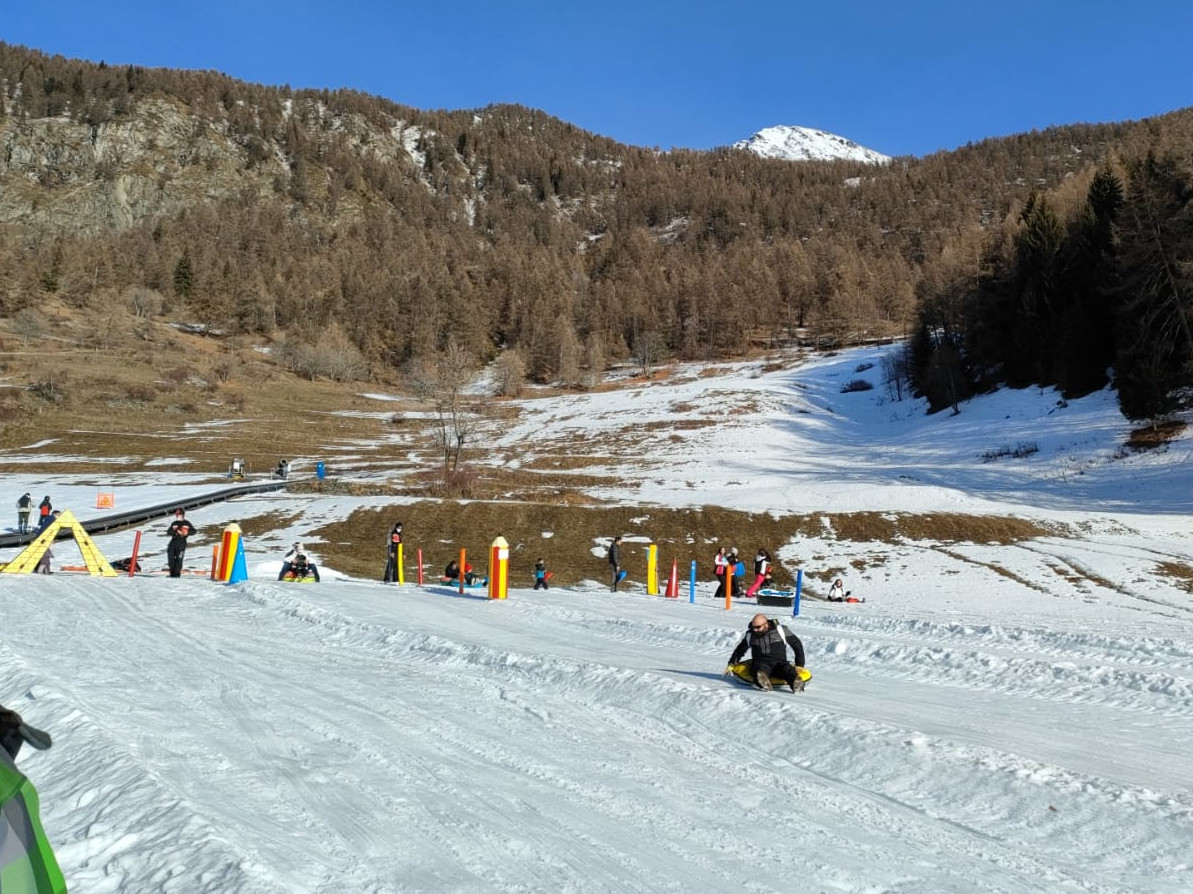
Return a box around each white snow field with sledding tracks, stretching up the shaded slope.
[0,349,1193,894]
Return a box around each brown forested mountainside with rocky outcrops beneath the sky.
[0,43,1193,405]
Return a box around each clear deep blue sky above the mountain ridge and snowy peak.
[0,0,1193,155]
